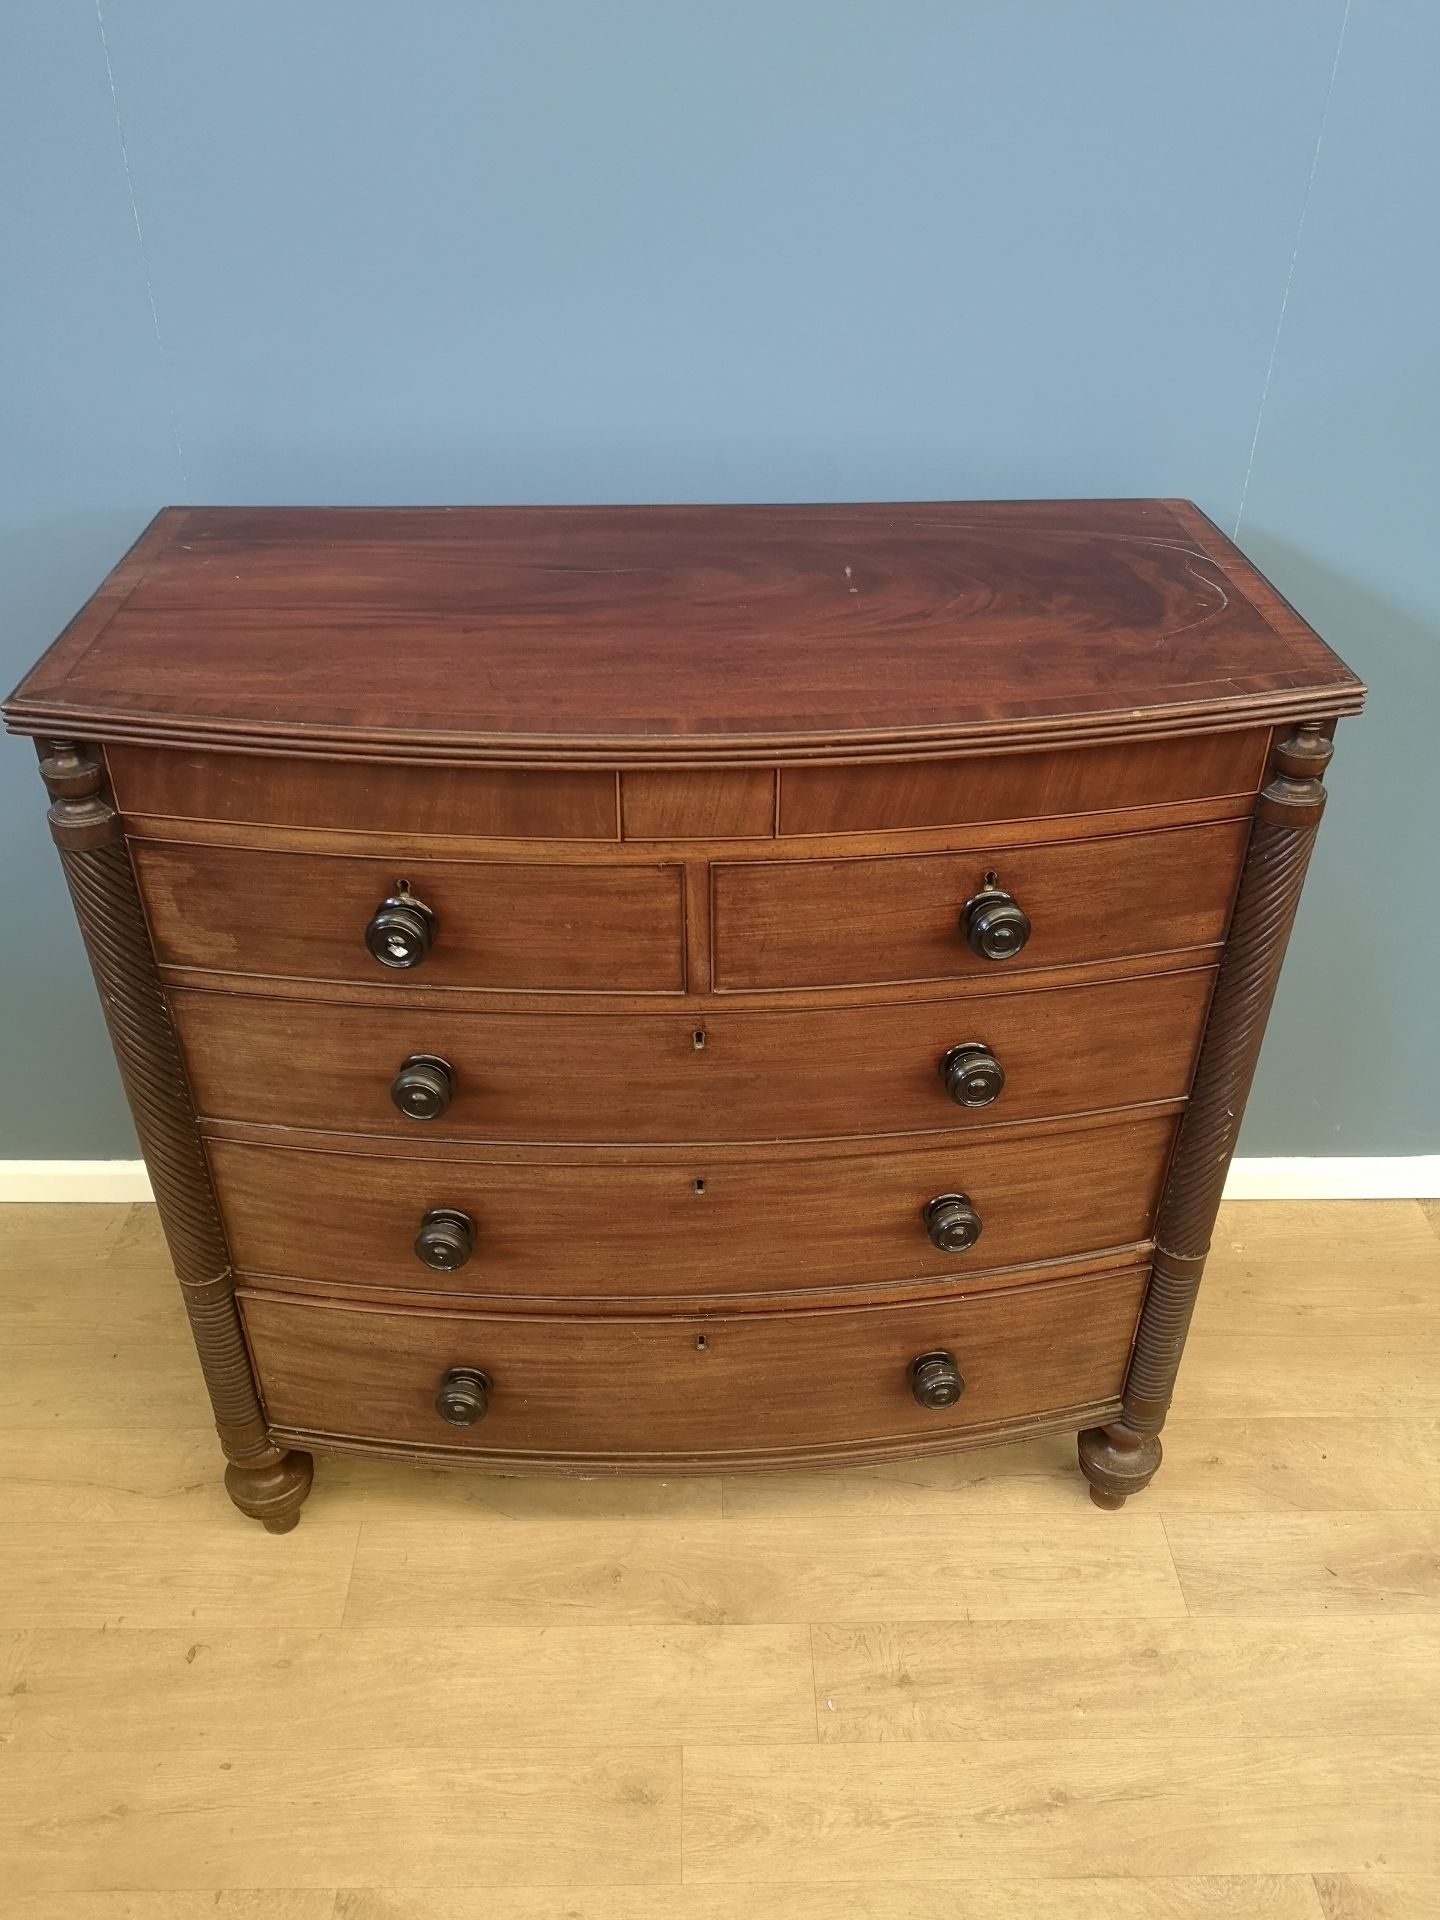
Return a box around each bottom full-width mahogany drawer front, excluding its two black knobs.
[240,1267,1148,1465]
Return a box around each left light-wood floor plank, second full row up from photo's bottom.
[13,1622,816,1753]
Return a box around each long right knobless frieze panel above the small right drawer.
[780,728,1269,835]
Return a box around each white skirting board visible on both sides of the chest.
[0,1154,1440,1202]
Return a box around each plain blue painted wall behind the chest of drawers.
[0,0,1440,1156]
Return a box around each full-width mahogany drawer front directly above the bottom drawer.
[209,1116,1175,1300]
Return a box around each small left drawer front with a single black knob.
[132,841,685,993]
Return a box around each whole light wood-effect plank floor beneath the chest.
[0,1202,1440,1920]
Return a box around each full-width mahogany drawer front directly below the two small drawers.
[171,968,1213,1142]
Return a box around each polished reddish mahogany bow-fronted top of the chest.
[6,501,1363,766]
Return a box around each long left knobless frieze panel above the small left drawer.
[106,747,620,841]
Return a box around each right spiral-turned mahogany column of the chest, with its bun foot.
[1079,722,1334,1507]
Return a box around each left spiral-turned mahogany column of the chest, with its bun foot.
[40,739,311,1534]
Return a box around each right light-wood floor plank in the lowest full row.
[685,1738,1440,1887]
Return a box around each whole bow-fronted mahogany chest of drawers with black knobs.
[6,501,1363,1532]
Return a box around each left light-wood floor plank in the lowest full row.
[0,1758,683,1895]
